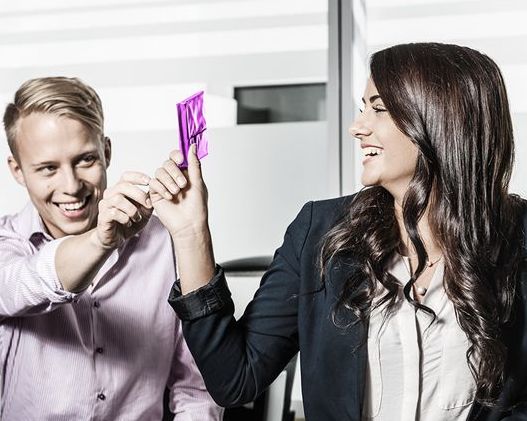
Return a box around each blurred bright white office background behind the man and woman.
[0,0,527,416]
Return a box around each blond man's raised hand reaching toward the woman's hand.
[92,171,153,249]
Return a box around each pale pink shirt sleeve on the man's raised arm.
[0,236,79,320]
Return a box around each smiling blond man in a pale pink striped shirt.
[0,77,223,421]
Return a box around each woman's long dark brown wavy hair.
[319,43,523,405]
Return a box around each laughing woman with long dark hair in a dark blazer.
[147,43,527,421]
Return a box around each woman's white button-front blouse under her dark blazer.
[363,258,476,421]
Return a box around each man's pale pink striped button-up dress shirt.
[0,204,223,421]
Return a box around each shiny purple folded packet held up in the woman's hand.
[177,91,209,168]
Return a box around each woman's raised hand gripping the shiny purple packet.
[150,145,208,243]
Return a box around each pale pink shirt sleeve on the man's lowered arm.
[168,321,224,421]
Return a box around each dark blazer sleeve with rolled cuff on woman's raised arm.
[169,202,313,407]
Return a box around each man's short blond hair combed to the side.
[4,76,104,158]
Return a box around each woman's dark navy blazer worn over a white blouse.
[169,197,527,421]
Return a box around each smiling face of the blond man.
[9,113,111,238]
